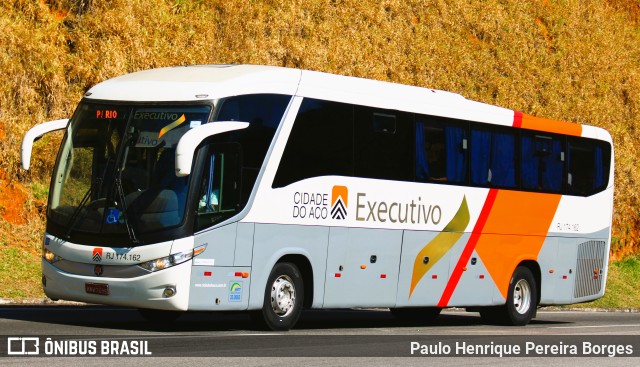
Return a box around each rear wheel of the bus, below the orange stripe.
[480,266,538,326]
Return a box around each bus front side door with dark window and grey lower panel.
[189,143,249,310]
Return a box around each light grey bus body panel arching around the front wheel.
[249,224,329,310]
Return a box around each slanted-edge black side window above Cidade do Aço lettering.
[273,99,353,188]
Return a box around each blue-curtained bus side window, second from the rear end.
[520,134,565,192]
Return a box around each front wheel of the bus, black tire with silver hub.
[251,263,304,331]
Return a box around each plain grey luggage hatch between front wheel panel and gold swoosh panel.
[323,227,402,308]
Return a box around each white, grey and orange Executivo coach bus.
[22,65,613,330]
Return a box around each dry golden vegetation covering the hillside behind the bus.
[0,0,640,298]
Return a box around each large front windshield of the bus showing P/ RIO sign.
[48,103,211,242]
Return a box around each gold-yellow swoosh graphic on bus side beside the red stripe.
[409,197,470,298]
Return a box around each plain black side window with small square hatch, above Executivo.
[354,106,413,181]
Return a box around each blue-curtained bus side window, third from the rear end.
[471,129,517,188]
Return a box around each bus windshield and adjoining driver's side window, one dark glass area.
[47,94,291,247]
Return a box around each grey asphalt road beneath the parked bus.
[0,305,640,367]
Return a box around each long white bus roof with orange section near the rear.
[85,65,611,141]
